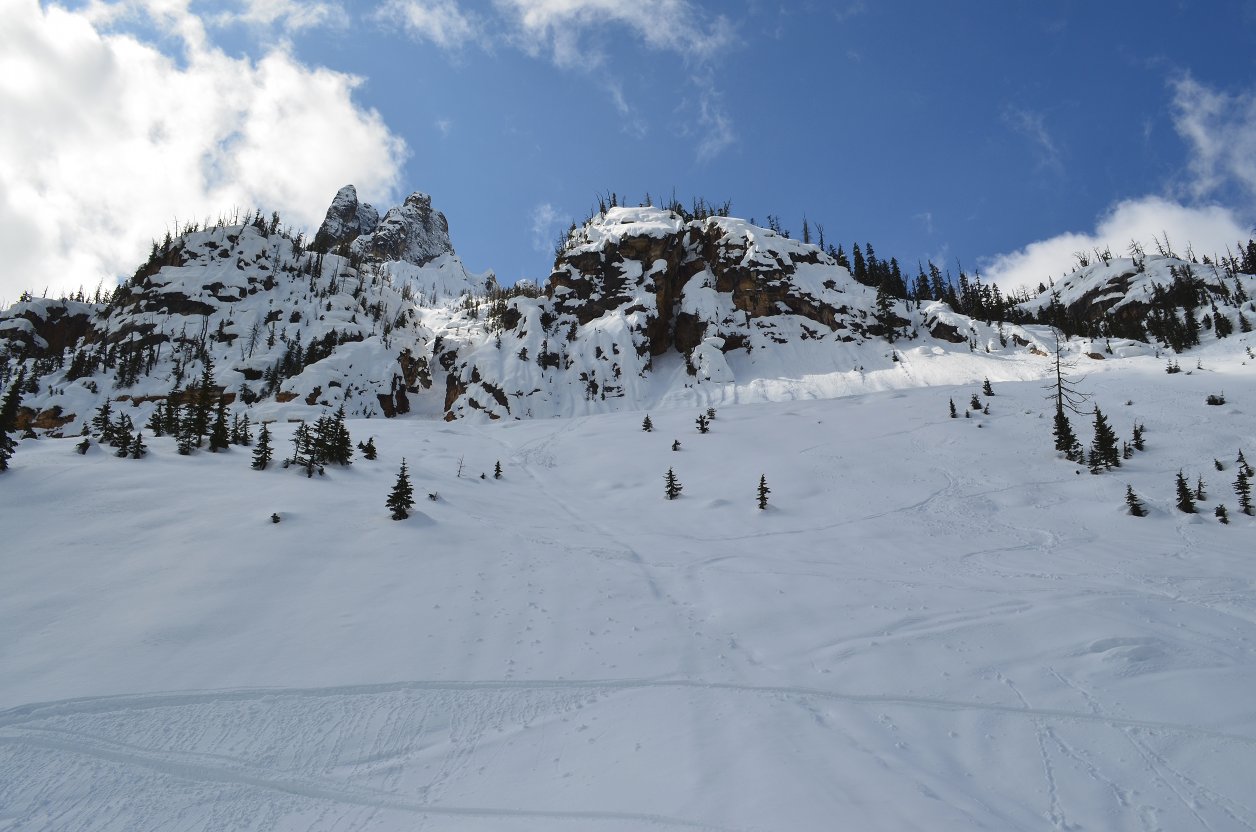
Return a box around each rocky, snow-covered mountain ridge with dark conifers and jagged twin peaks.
[0,186,1256,434]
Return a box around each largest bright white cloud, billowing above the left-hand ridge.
[0,0,406,300]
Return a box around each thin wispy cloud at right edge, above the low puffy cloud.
[1171,75,1256,204]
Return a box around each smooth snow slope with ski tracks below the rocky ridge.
[0,339,1256,832]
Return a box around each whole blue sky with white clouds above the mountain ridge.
[0,0,1256,300]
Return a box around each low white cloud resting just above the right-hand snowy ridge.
[982,196,1251,293]
